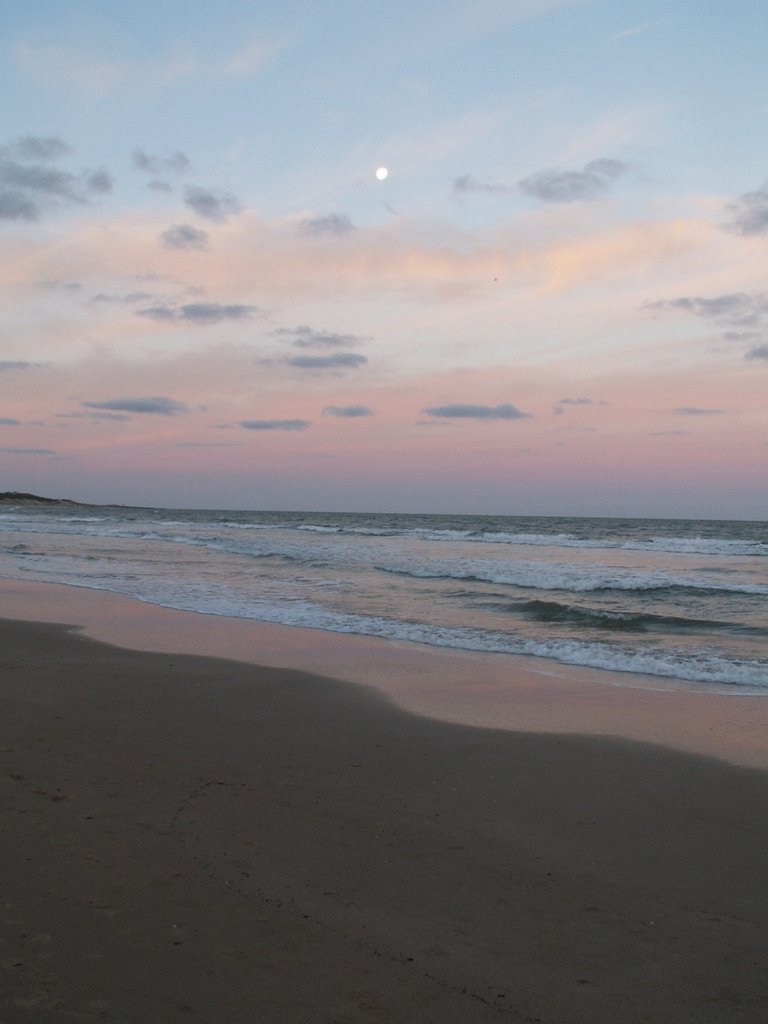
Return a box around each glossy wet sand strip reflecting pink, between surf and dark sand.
[0,579,768,769]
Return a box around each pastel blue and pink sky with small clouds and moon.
[0,0,768,519]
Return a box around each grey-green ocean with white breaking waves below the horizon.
[0,504,768,694]
